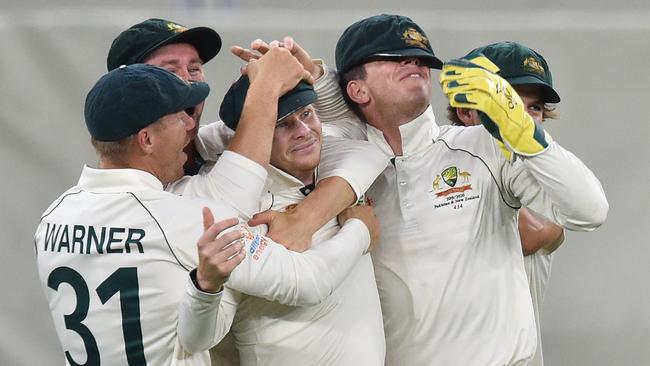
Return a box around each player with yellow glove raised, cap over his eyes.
[308,14,608,365]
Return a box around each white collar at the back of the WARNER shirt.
[77,165,163,192]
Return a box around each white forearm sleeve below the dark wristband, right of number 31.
[177,277,242,353]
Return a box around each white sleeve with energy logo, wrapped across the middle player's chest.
[225,219,370,306]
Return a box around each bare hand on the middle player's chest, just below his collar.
[248,206,314,253]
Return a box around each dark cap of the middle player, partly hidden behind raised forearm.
[219,75,316,131]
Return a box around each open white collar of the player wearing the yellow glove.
[367,105,440,156]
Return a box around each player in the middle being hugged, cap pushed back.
[180,76,387,366]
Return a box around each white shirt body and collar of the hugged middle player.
[233,165,385,366]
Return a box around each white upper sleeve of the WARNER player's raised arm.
[165,151,268,220]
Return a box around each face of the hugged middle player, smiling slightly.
[271,105,322,184]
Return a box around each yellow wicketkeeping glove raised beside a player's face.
[440,56,552,160]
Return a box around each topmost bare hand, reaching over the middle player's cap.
[230,36,323,80]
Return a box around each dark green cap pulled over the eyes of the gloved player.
[336,14,442,73]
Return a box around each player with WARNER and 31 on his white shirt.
[35,59,378,365]
